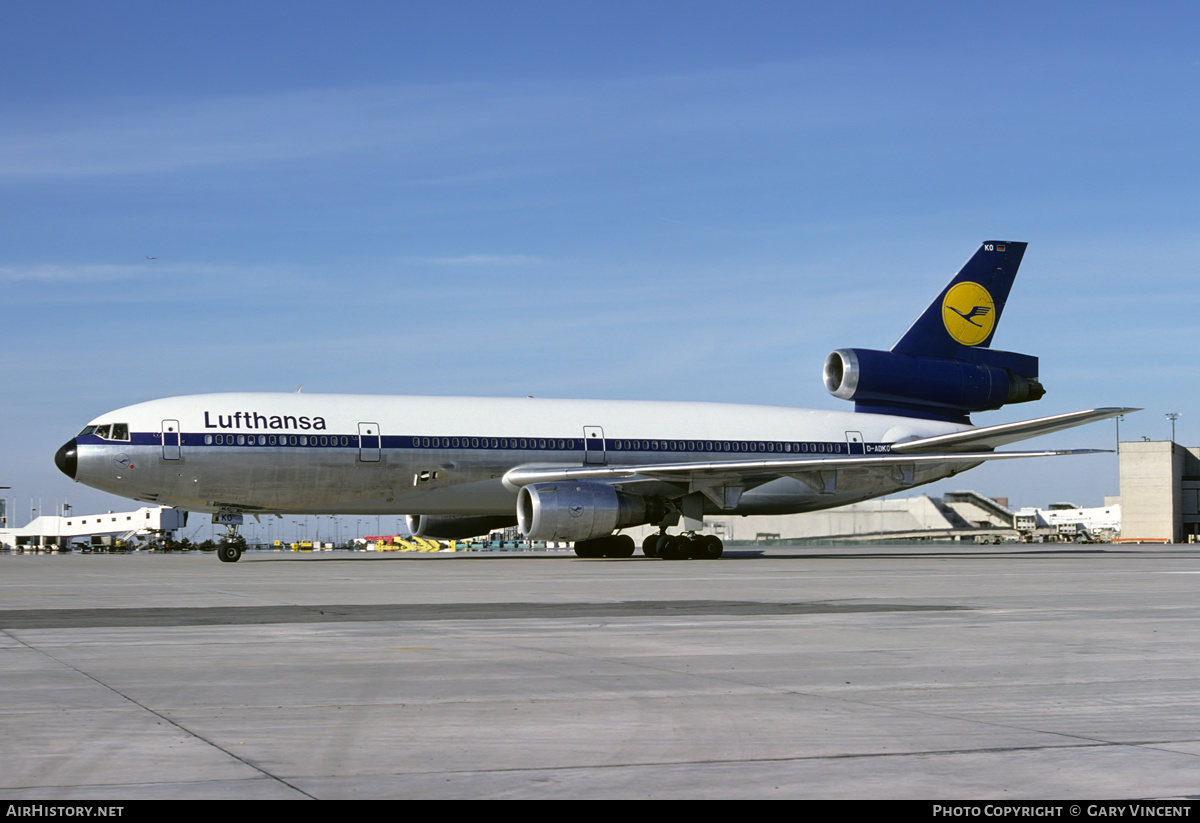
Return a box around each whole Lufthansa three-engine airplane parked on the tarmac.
[54,241,1136,563]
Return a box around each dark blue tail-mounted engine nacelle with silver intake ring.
[824,349,1045,415]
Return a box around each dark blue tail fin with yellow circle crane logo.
[892,241,1028,358]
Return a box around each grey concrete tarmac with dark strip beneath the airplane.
[0,546,1200,800]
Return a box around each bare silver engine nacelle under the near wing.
[517,481,665,542]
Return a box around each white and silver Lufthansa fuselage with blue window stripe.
[65,394,971,516]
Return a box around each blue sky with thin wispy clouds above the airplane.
[0,1,1200,527]
